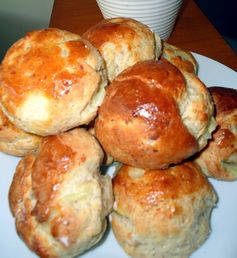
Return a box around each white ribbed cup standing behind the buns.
[96,0,182,40]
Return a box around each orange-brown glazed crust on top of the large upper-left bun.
[2,29,90,99]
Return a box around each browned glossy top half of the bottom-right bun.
[113,162,216,213]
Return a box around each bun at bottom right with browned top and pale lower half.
[112,163,217,258]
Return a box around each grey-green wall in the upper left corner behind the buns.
[0,0,54,61]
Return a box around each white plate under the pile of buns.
[0,54,237,258]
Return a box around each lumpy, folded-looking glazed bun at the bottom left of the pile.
[9,129,113,257]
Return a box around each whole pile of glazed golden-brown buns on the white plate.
[0,18,237,258]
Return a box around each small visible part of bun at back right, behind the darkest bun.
[161,41,198,74]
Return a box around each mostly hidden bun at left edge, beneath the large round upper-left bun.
[0,106,42,157]
